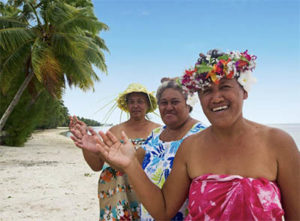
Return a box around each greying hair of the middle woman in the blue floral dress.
[156,78,193,113]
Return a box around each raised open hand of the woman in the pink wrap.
[97,131,136,169]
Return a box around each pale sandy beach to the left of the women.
[0,128,99,221]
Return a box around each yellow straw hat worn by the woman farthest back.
[117,83,157,113]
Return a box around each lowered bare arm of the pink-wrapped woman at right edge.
[272,130,300,220]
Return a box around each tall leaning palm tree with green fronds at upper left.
[0,0,108,133]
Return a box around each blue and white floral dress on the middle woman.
[141,122,205,221]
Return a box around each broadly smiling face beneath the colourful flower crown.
[198,79,248,127]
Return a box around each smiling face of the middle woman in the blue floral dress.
[158,88,189,128]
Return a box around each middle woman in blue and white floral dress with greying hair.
[141,79,205,221]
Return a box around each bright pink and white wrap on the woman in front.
[185,174,284,221]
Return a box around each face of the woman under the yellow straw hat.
[127,92,149,119]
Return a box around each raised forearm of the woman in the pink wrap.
[125,159,175,220]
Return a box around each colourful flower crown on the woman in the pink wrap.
[179,49,256,93]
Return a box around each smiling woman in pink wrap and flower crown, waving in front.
[92,50,300,220]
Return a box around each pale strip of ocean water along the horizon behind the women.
[67,123,300,151]
